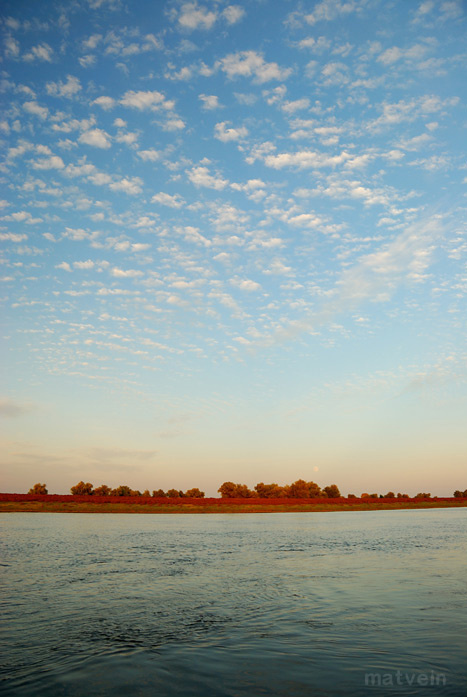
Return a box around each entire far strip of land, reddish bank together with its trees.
[0,479,467,513]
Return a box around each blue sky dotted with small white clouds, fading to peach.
[0,0,467,496]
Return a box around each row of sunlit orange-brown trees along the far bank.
[28,479,467,500]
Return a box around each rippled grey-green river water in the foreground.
[0,509,467,697]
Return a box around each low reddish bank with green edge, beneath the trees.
[0,499,467,515]
